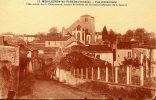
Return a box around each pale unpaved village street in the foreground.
[28,80,108,99]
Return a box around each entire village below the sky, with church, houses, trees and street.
[0,14,156,100]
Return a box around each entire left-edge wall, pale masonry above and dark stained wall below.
[0,46,19,99]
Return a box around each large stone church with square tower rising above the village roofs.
[62,15,95,44]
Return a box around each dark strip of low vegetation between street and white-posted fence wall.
[77,81,153,100]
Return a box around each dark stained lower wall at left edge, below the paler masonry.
[0,60,19,99]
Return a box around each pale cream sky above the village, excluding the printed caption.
[0,0,156,34]
